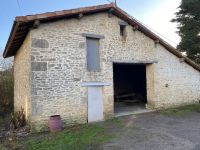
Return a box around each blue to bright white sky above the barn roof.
[0,0,181,55]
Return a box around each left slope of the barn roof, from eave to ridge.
[3,3,115,58]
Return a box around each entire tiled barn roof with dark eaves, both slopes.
[3,3,200,71]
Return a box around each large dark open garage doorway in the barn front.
[113,63,147,116]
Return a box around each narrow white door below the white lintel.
[88,86,103,122]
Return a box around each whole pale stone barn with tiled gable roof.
[3,4,200,130]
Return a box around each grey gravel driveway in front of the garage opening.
[98,112,200,150]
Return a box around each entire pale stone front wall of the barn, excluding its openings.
[24,13,200,130]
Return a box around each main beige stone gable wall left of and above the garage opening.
[31,13,155,130]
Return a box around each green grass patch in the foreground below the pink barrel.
[1,125,112,150]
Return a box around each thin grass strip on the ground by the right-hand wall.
[160,104,200,116]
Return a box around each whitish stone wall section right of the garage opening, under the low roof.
[154,45,200,108]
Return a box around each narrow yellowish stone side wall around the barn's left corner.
[14,33,31,119]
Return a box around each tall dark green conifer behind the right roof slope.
[172,0,200,64]
